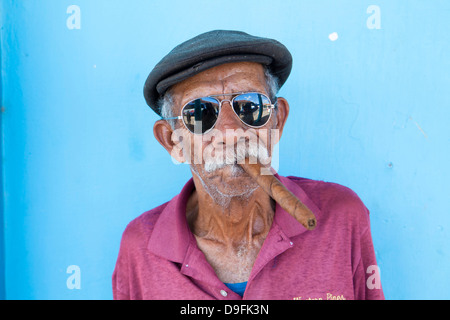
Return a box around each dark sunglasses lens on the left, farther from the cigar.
[182,97,219,133]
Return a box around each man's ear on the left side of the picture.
[153,120,185,163]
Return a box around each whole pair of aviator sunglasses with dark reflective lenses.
[161,92,276,134]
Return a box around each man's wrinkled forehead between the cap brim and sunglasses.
[170,62,266,106]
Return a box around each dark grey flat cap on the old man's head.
[144,30,292,115]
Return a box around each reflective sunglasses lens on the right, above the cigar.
[233,93,272,127]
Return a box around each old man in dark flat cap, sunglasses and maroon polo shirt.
[113,30,384,300]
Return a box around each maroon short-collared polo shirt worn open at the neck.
[112,175,384,300]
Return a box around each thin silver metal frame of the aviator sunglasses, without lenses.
[161,91,277,134]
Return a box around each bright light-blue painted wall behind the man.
[0,0,450,299]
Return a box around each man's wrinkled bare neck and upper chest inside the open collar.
[186,179,275,282]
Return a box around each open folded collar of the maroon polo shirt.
[147,174,321,263]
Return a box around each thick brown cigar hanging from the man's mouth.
[241,163,317,230]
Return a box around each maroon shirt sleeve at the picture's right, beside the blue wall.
[353,222,384,300]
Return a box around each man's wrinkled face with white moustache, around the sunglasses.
[156,62,286,204]
